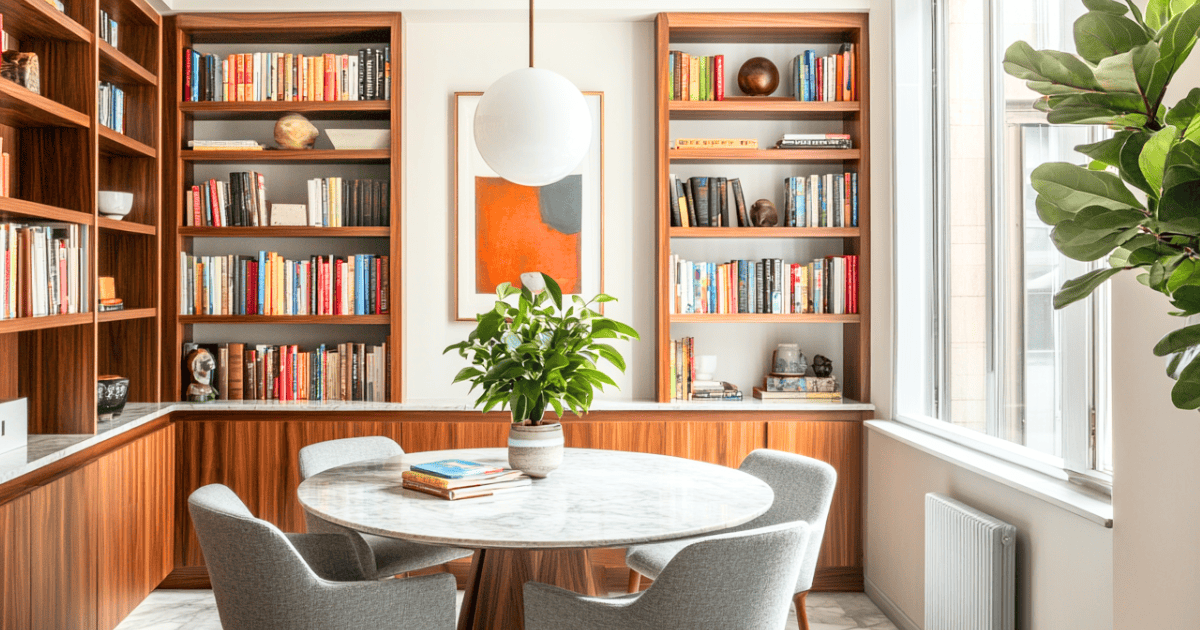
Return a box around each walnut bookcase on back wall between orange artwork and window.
[655,13,871,402]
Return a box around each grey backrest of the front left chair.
[187,484,318,630]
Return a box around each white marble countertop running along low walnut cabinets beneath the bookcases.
[0,398,875,484]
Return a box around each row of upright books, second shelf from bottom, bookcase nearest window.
[670,254,858,314]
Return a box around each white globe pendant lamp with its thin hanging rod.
[475,0,592,186]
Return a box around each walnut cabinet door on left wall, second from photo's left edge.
[29,463,103,630]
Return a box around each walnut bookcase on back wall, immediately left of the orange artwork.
[162,13,404,401]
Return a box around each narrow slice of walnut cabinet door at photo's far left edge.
[0,496,30,630]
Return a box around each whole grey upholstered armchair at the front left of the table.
[187,484,456,630]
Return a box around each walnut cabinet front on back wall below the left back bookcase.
[174,421,401,568]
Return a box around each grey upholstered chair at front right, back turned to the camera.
[524,522,809,630]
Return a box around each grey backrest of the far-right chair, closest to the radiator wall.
[738,449,838,593]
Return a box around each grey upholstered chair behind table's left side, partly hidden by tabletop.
[300,436,472,577]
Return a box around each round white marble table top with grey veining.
[298,449,774,550]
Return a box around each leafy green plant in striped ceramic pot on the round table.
[443,274,638,478]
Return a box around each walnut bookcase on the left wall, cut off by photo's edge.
[0,0,162,433]
